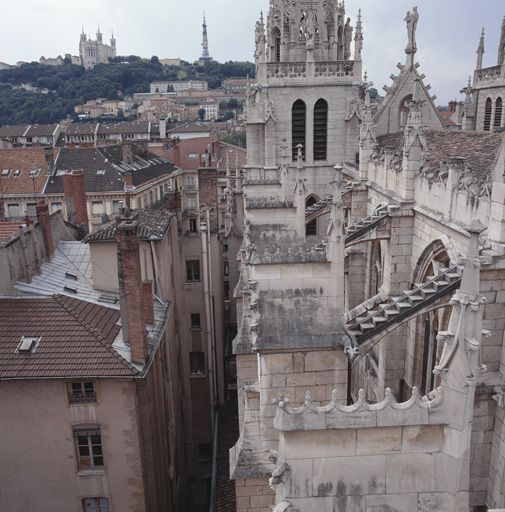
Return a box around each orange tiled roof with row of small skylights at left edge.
[0,148,58,195]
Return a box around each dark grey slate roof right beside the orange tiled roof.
[45,145,175,194]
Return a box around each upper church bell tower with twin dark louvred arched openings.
[247,0,363,197]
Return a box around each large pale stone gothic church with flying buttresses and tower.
[225,0,505,512]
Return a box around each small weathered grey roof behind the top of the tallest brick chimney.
[84,210,174,242]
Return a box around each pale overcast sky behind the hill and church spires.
[0,0,505,104]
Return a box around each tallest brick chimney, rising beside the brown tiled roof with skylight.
[116,217,148,364]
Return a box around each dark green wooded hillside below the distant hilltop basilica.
[0,56,254,125]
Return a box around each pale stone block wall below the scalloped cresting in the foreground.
[277,426,454,512]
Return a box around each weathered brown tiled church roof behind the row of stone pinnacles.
[377,130,503,175]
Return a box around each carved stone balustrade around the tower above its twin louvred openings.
[267,60,354,79]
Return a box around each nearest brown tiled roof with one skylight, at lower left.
[0,295,138,379]
